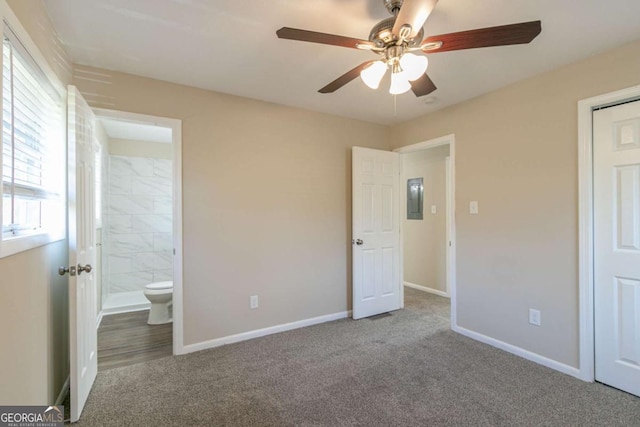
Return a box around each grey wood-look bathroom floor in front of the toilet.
[98,310,173,371]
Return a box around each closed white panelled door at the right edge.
[593,101,640,396]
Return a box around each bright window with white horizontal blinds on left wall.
[0,23,66,256]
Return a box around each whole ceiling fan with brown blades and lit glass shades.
[276,0,542,96]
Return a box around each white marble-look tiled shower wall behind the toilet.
[103,155,173,294]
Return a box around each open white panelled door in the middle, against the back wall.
[352,147,401,319]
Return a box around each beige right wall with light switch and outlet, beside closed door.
[392,41,640,367]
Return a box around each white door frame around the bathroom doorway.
[93,108,185,355]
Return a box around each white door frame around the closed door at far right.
[578,85,640,382]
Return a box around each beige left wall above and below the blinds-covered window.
[0,0,69,405]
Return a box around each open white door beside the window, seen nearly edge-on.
[67,86,98,422]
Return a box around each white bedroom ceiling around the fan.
[44,0,640,124]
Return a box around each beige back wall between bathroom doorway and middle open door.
[74,67,389,345]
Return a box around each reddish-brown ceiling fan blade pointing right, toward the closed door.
[422,21,542,53]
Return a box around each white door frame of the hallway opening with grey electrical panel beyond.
[393,134,458,329]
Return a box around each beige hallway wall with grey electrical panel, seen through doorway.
[401,145,449,292]
